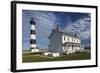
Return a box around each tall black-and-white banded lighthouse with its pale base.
[30,17,39,52]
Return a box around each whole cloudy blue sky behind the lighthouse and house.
[22,10,91,50]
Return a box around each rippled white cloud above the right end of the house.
[62,17,91,40]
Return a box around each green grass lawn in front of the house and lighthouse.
[22,52,91,63]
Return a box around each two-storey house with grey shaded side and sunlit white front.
[49,27,84,55]
